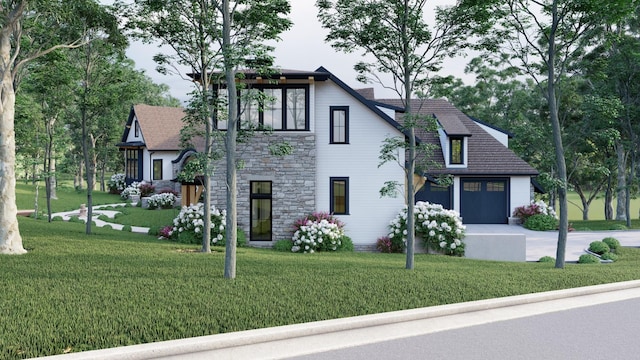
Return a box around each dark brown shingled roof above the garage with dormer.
[376,99,538,176]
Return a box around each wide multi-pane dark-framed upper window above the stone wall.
[216,85,309,131]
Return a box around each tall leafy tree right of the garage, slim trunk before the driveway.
[462,0,632,268]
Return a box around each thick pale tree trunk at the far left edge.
[0,21,27,254]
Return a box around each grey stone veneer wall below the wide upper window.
[211,132,316,246]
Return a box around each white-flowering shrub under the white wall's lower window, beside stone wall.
[291,212,346,253]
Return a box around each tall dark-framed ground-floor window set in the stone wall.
[249,181,272,241]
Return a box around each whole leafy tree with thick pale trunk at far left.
[0,0,121,254]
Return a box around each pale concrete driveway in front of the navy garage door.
[466,224,640,261]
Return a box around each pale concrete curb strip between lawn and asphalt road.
[36,280,640,360]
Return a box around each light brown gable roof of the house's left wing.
[118,104,198,151]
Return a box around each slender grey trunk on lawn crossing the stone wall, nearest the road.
[222,0,238,279]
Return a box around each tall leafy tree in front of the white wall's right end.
[316,0,483,269]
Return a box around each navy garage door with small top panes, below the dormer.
[460,179,509,224]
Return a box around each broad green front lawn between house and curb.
[0,218,640,359]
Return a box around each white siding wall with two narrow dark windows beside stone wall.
[314,81,404,245]
